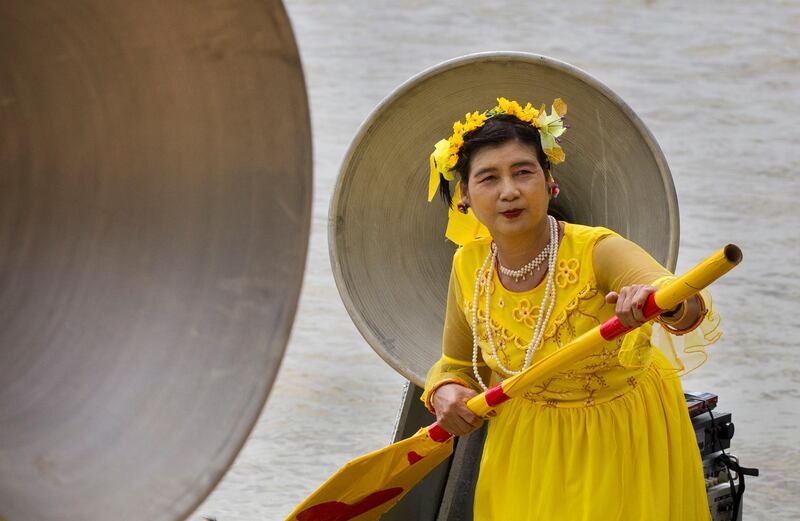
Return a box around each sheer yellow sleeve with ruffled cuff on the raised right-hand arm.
[592,236,722,376]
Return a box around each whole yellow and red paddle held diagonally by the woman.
[286,244,742,521]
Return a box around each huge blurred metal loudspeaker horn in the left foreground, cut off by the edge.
[0,0,311,521]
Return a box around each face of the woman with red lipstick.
[462,141,549,239]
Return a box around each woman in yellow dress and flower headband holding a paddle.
[423,98,712,521]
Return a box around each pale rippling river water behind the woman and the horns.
[191,0,800,521]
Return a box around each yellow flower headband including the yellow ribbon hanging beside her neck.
[428,98,569,246]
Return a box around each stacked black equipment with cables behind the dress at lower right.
[684,392,758,521]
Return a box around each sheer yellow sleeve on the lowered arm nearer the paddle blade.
[421,269,491,412]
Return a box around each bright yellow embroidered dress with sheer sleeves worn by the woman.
[423,223,718,521]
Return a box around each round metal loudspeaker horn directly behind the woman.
[329,53,678,385]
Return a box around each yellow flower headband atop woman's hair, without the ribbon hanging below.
[428,98,569,202]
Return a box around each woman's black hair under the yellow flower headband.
[439,114,550,207]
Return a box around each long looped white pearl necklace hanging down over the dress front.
[472,216,558,390]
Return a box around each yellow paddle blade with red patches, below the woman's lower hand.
[286,428,453,521]
